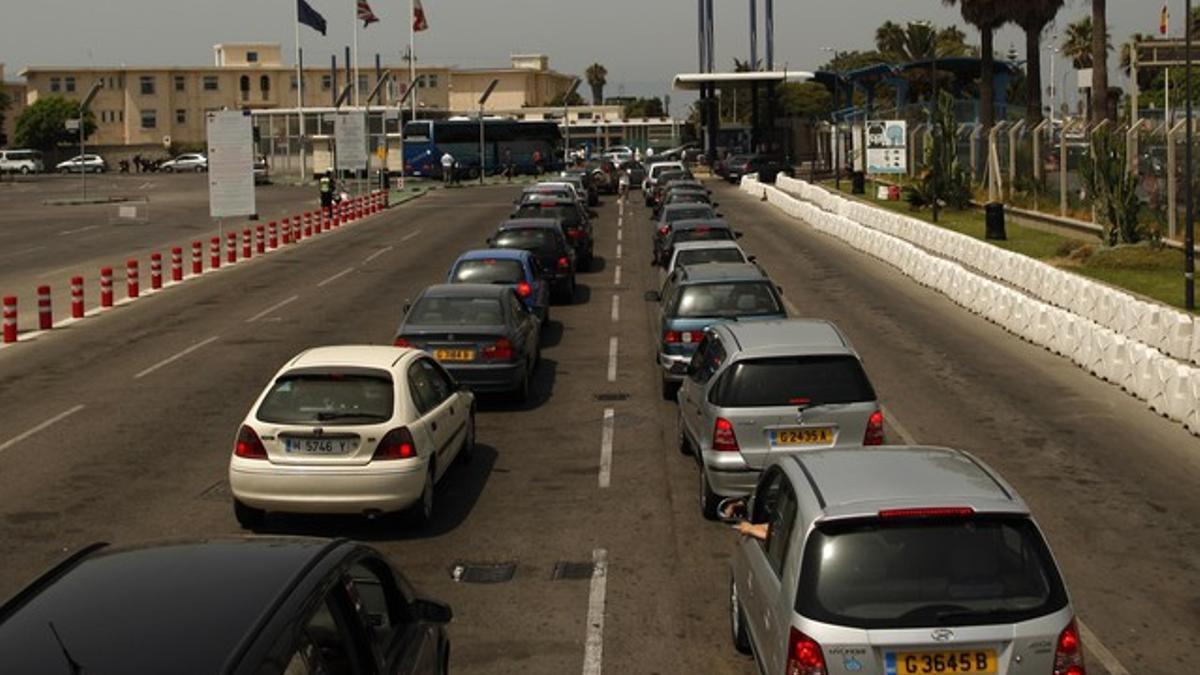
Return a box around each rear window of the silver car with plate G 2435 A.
[713,354,875,408]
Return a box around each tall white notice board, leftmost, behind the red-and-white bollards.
[205,110,258,217]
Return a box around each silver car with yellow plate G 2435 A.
[677,318,884,519]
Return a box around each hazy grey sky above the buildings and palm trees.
[0,0,1183,100]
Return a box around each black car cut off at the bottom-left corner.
[0,538,451,675]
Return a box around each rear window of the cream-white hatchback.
[257,372,394,425]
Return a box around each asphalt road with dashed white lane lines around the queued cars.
[0,176,1200,675]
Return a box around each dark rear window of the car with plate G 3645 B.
[796,515,1067,628]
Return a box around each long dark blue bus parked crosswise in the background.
[404,118,563,178]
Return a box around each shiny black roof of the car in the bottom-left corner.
[0,537,352,673]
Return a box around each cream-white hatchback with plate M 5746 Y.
[229,346,475,528]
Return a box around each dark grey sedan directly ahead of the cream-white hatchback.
[395,283,541,401]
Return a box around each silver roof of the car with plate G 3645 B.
[785,446,1030,520]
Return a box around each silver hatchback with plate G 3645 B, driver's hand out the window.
[730,447,1085,675]
